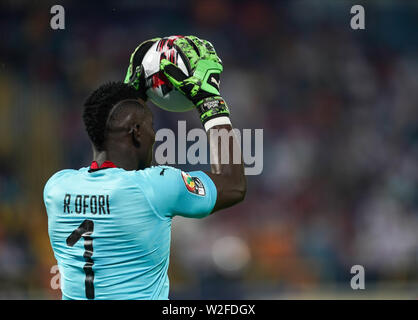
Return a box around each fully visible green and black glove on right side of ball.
[160,36,229,124]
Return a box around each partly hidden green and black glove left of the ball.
[124,38,161,101]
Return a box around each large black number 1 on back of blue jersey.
[67,219,94,299]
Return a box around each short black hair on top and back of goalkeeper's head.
[83,82,140,151]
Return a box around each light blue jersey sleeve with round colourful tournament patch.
[139,166,217,218]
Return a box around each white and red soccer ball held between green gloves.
[142,36,194,112]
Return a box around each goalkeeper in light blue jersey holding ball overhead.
[44,36,246,299]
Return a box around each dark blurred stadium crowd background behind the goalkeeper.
[0,0,418,299]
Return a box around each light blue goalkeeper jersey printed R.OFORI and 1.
[44,162,217,300]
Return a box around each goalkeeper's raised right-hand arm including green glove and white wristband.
[160,36,247,212]
